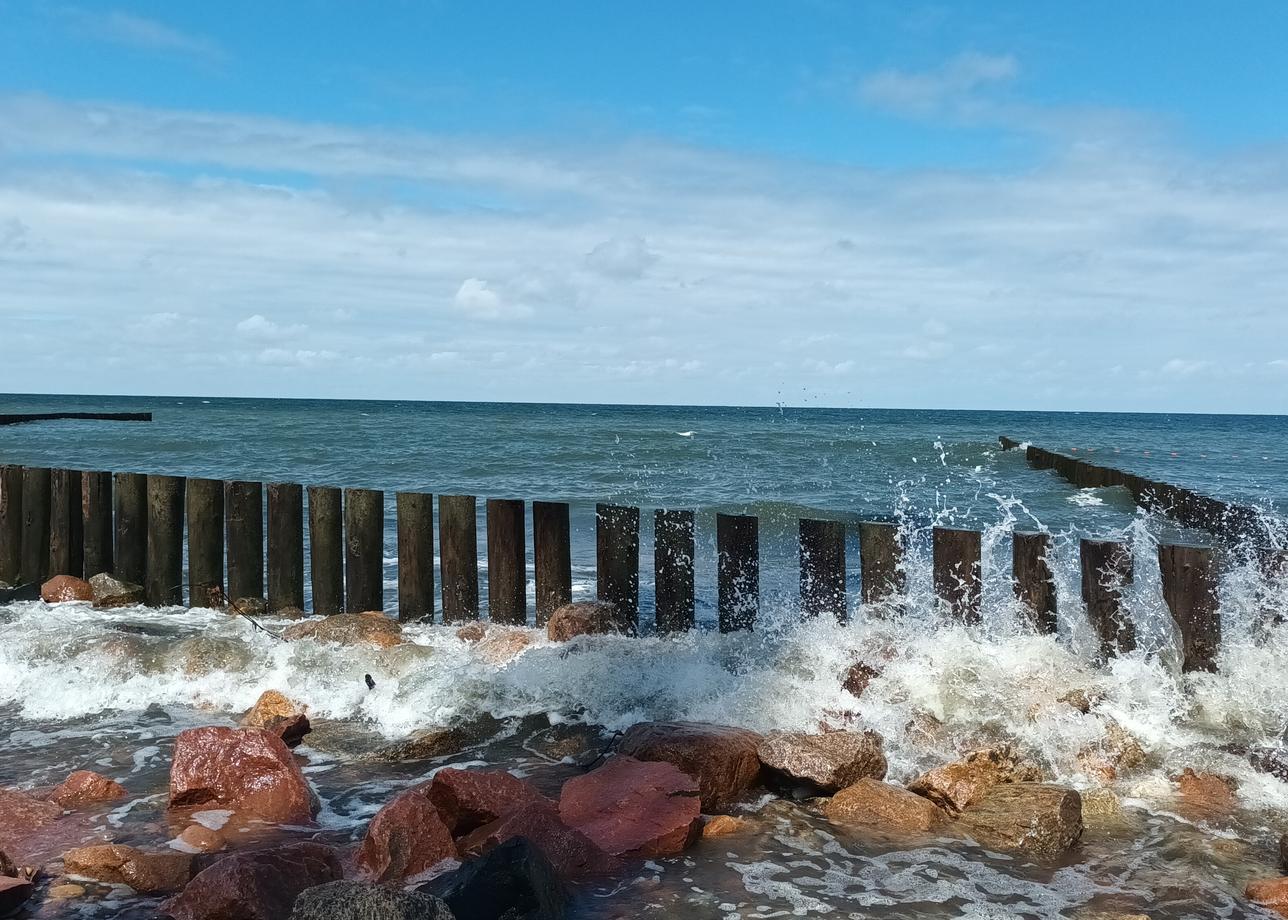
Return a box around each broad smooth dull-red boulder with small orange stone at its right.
[559,756,701,858]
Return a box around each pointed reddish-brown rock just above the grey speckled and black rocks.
[358,786,456,881]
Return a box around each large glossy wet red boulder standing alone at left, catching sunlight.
[170,725,318,825]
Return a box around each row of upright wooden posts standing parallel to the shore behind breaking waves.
[0,466,1221,670]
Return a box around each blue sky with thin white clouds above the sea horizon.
[0,0,1288,414]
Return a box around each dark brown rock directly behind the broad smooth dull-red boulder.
[617,722,761,814]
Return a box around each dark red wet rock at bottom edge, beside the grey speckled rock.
[161,843,344,920]
